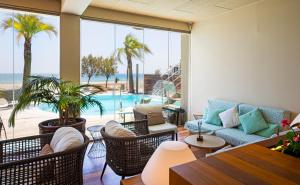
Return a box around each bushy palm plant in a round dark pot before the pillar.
[9,76,103,134]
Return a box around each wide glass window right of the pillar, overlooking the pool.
[81,20,181,125]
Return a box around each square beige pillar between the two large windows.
[60,14,80,83]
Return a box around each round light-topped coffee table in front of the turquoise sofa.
[184,134,226,152]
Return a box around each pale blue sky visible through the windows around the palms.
[0,9,181,77]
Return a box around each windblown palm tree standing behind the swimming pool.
[117,34,151,93]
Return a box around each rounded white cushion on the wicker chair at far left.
[50,127,84,152]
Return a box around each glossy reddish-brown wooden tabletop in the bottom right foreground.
[170,144,300,185]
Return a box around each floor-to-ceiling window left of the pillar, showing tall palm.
[0,9,59,138]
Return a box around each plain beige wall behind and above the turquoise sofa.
[190,0,300,115]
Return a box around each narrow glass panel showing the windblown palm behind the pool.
[115,25,145,122]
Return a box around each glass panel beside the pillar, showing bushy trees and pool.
[81,20,119,126]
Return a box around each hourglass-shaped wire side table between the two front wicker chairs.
[87,125,106,158]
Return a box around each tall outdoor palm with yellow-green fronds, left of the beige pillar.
[0,14,57,89]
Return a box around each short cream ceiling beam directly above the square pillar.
[61,0,92,15]
